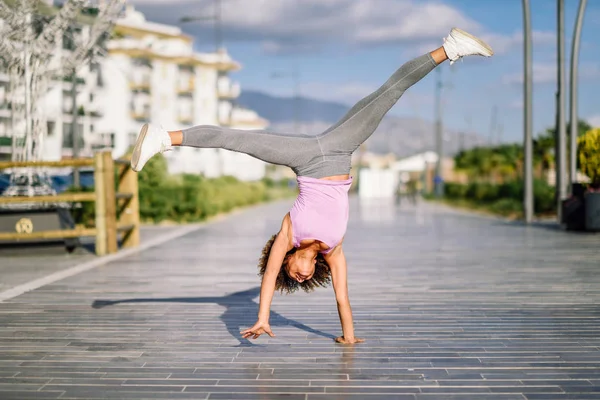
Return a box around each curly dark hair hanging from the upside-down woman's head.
[258,235,331,294]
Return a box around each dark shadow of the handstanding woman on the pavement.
[92,287,336,346]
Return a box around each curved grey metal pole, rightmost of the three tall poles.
[569,0,587,191]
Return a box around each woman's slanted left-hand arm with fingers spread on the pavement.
[242,214,291,339]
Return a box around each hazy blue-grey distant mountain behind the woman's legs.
[238,90,485,157]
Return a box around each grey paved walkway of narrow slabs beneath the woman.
[0,199,600,400]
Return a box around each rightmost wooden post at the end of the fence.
[118,159,140,247]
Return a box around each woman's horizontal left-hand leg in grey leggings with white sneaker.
[131,125,321,171]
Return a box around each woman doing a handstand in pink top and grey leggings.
[131,28,493,343]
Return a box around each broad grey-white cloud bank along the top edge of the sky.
[130,0,524,53]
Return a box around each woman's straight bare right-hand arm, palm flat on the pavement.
[325,244,364,343]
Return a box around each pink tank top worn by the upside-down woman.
[290,176,352,254]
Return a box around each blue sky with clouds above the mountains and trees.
[132,0,600,141]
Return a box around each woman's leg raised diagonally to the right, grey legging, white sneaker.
[319,29,493,155]
